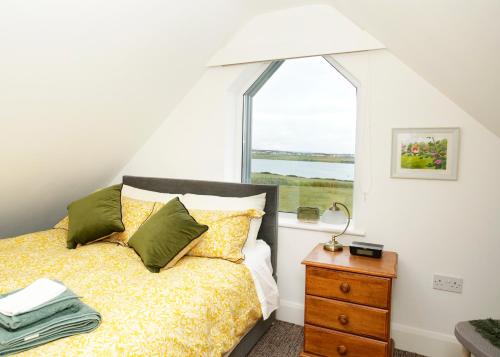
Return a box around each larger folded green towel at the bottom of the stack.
[0,288,101,356]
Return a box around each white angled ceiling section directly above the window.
[208,3,384,66]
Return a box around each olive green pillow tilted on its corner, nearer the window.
[128,197,208,273]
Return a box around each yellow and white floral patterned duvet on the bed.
[0,229,262,356]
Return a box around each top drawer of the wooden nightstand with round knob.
[306,266,391,308]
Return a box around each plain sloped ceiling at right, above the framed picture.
[331,0,500,136]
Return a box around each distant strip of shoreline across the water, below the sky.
[252,150,354,164]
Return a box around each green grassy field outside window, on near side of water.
[252,172,353,213]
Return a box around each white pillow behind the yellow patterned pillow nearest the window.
[180,192,266,248]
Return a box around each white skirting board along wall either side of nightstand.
[276,299,461,357]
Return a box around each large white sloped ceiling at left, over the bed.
[0,0,312,237]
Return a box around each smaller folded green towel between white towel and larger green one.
[0,289,80,331]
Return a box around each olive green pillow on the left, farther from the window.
[66,184,125,249]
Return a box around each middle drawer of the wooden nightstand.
[305,295,389,340]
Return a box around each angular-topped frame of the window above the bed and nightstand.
[241,56,361,221]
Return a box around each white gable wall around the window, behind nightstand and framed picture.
[116,46,500,356]
